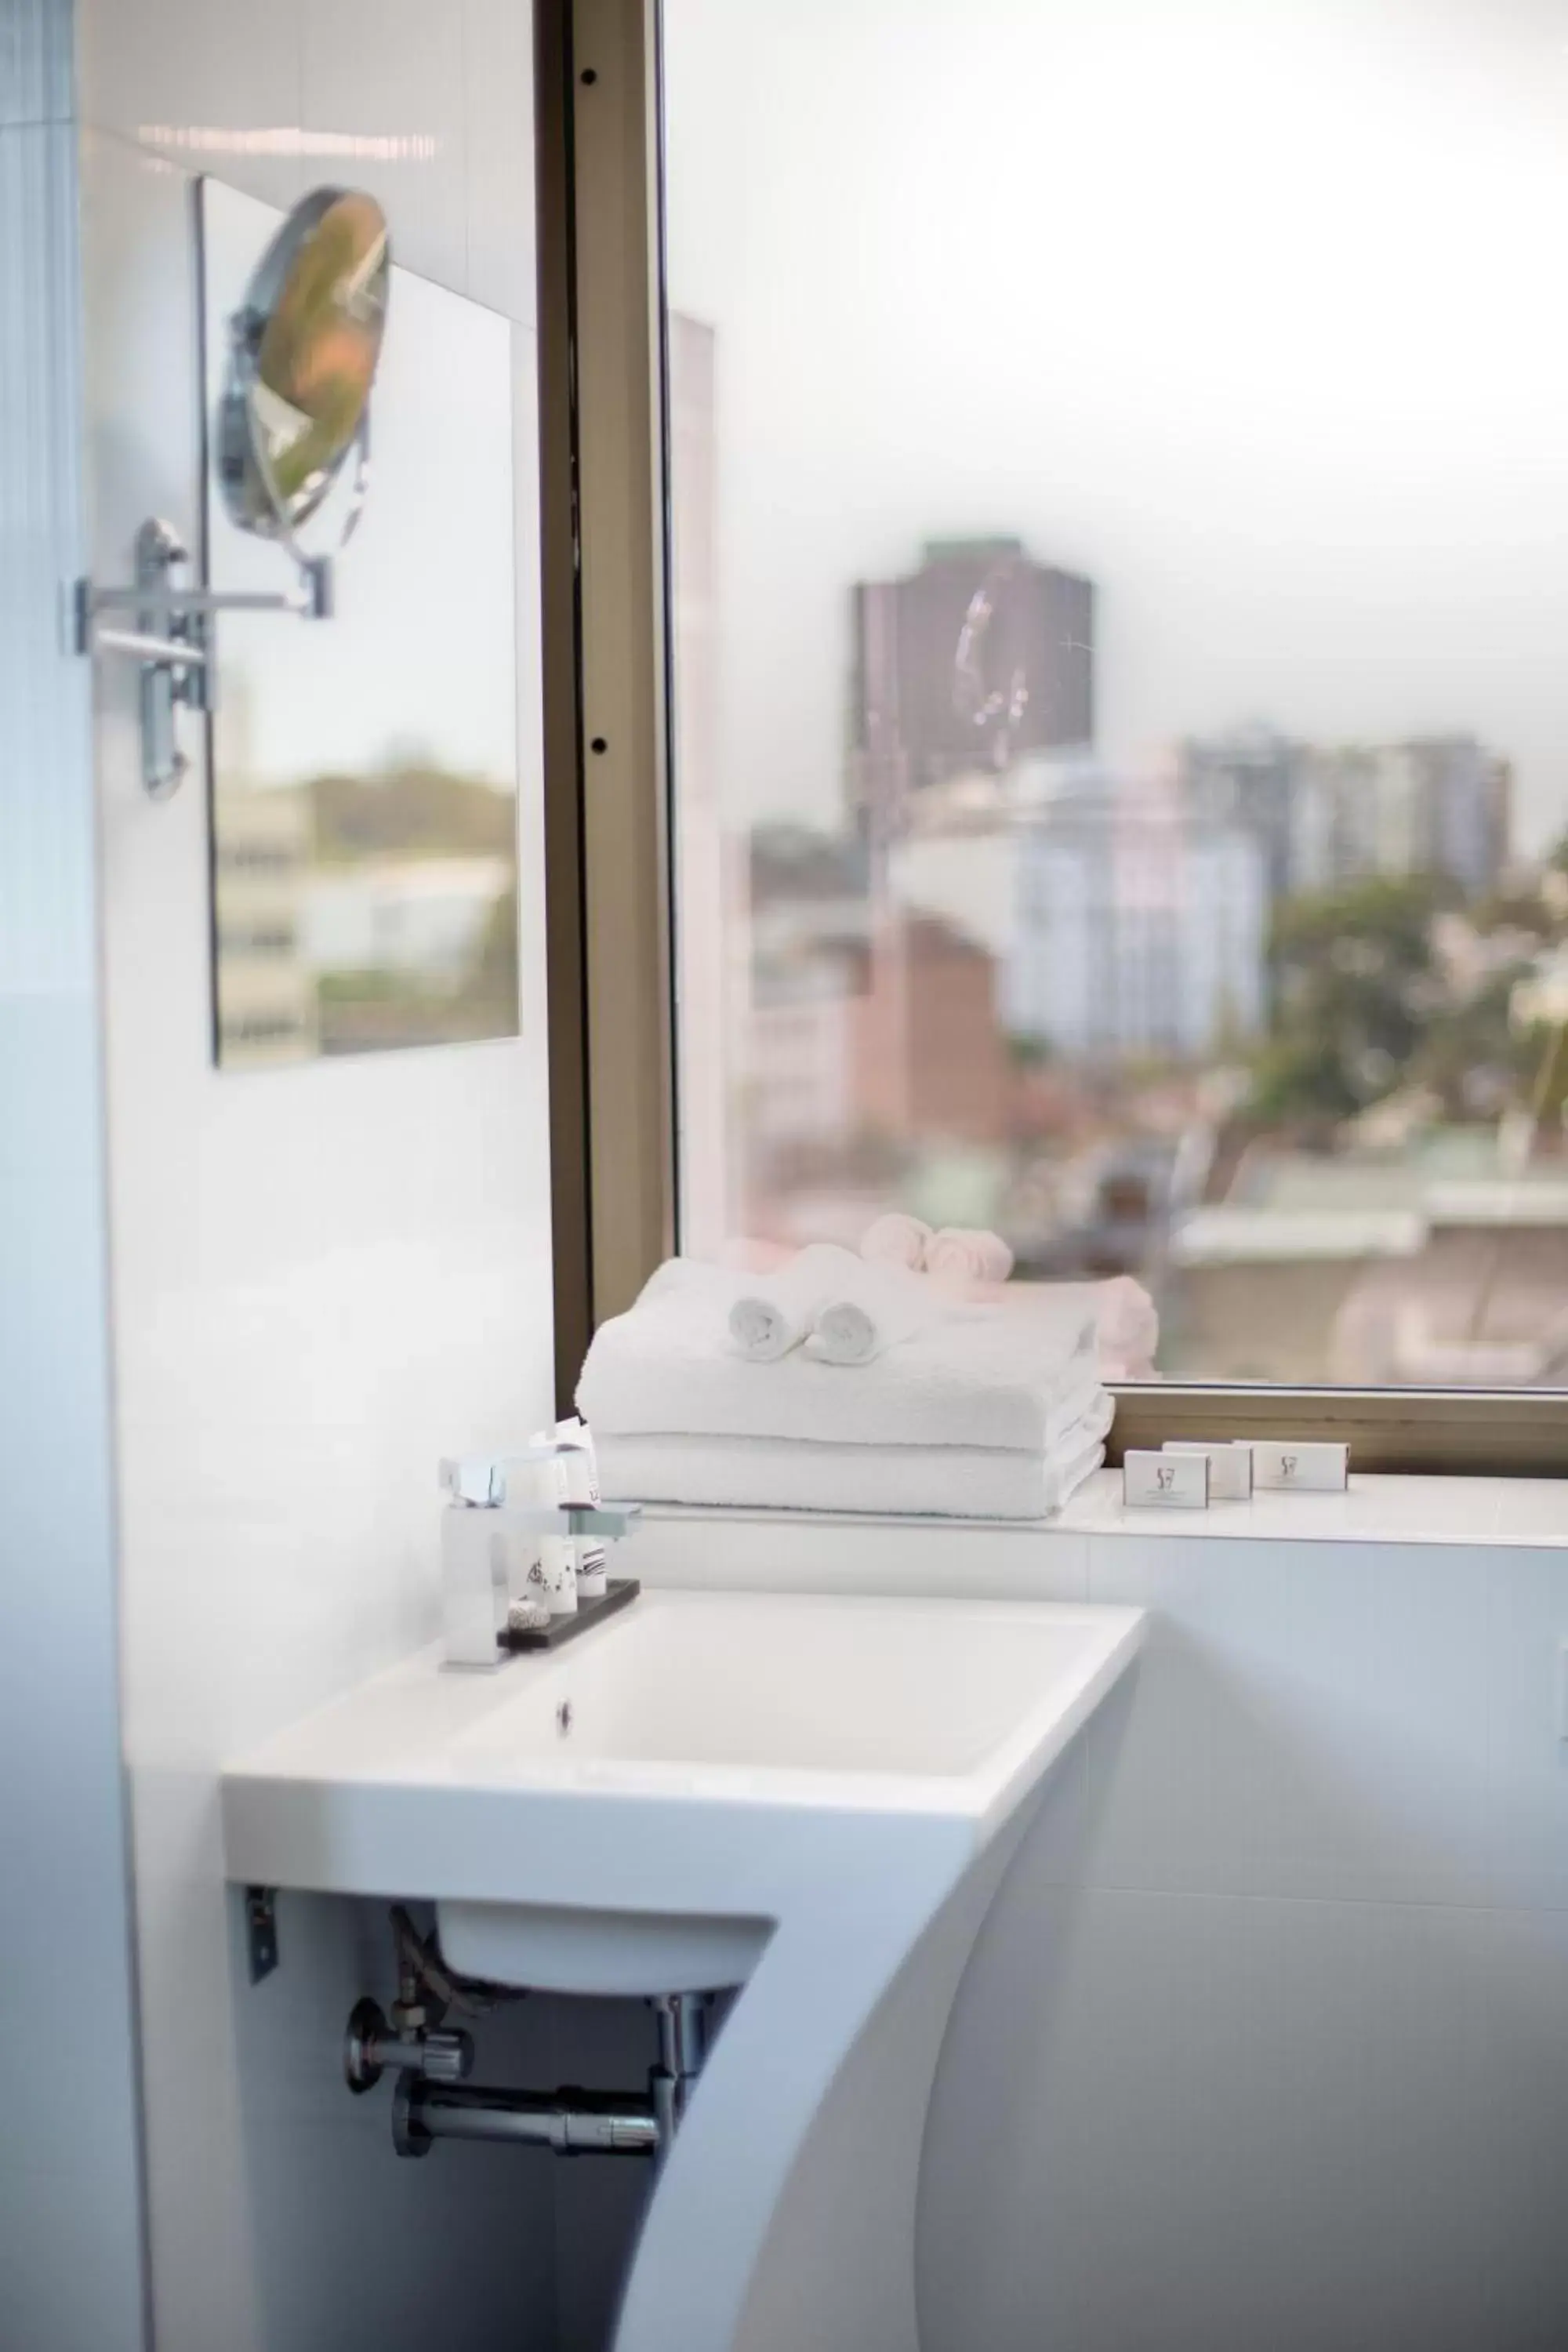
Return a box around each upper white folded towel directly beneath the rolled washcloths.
[576,1258,1098,1454]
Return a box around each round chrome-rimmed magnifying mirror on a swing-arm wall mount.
[219,188,390,562]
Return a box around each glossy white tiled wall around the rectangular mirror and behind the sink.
[74,0,555,2352]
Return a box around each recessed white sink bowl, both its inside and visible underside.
[437,1592,1142,1992]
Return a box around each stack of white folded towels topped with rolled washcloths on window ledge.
[579,1247,1112,1519]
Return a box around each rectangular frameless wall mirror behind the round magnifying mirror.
[202,181,520,1070]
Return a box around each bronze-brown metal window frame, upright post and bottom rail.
[534,0,1568,1477]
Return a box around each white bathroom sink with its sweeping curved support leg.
[223,1581,1142,2352]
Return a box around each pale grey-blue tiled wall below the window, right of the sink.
[921,1534,1568,2352]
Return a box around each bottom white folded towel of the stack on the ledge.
[597,1399,1109,1519]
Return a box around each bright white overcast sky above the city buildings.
[666,0,1568,849]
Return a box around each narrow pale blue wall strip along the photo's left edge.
[0,50,143,2352]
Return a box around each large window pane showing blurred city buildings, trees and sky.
[666,0,1568,1388]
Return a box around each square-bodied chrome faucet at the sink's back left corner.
[440,1437,640,1672]
